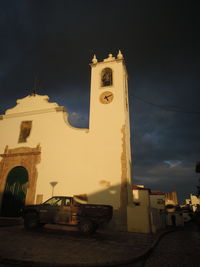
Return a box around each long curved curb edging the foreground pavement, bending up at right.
[0,229,176,267]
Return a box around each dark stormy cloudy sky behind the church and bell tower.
[0,0,200,201]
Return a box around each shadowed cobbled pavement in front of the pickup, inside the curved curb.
[0,219,172,267]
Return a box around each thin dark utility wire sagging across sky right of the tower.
[133,94,200,114]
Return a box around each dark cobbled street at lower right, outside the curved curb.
[142,223,200,267]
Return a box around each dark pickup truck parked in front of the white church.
[22,196,113,234]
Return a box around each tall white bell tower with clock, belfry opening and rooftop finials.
[89,51,132,229]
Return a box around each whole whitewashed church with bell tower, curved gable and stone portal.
[0,51,133,231]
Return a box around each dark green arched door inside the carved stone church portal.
[1,166,28,217]
